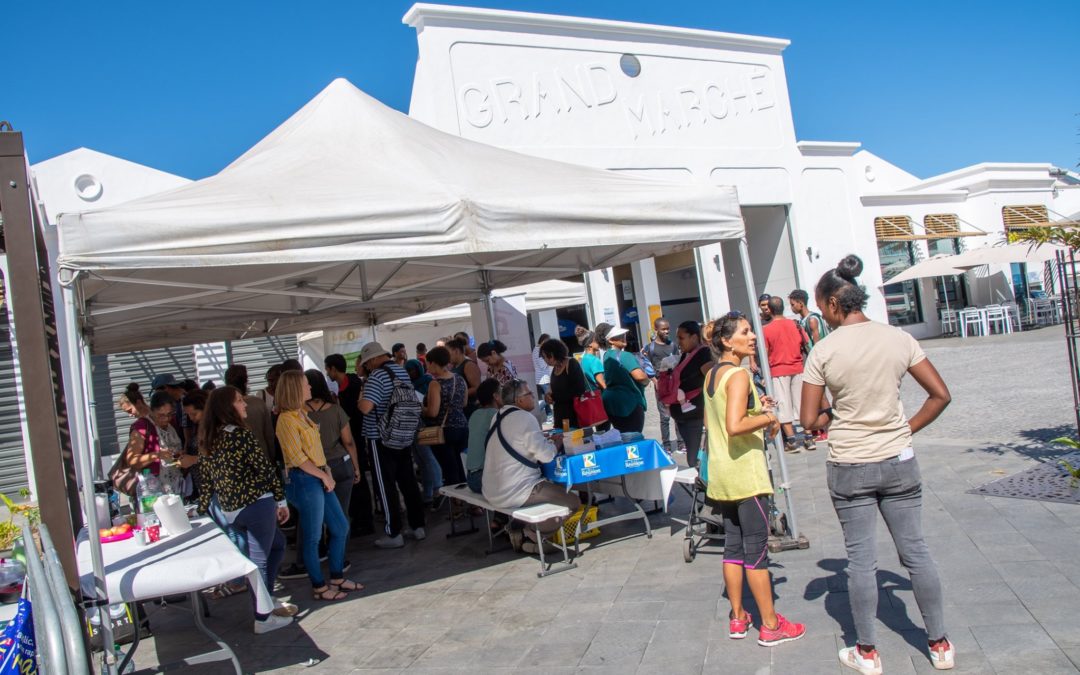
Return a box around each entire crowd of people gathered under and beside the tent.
[109,256,954,673]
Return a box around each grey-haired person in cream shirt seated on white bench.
[482,379,581,553]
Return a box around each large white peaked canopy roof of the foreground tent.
[58,80,743,352]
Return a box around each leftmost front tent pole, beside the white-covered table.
[60,282,117,675]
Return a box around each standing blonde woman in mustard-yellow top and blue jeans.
[274,370,364,600]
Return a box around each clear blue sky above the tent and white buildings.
[0,0,1080,178]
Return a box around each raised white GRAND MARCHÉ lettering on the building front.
[458,63,775,139]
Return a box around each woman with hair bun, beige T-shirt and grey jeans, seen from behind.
[800,256,955,673]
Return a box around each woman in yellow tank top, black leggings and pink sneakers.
[705,312,806,647]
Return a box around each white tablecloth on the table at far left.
[77,518,273,613]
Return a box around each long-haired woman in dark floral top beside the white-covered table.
[199,387,295,633]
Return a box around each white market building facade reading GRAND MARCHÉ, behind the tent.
[404,4,1080,341]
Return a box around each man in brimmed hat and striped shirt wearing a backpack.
[359,342,427,549]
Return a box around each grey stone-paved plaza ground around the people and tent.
[128,326,1080,675]
